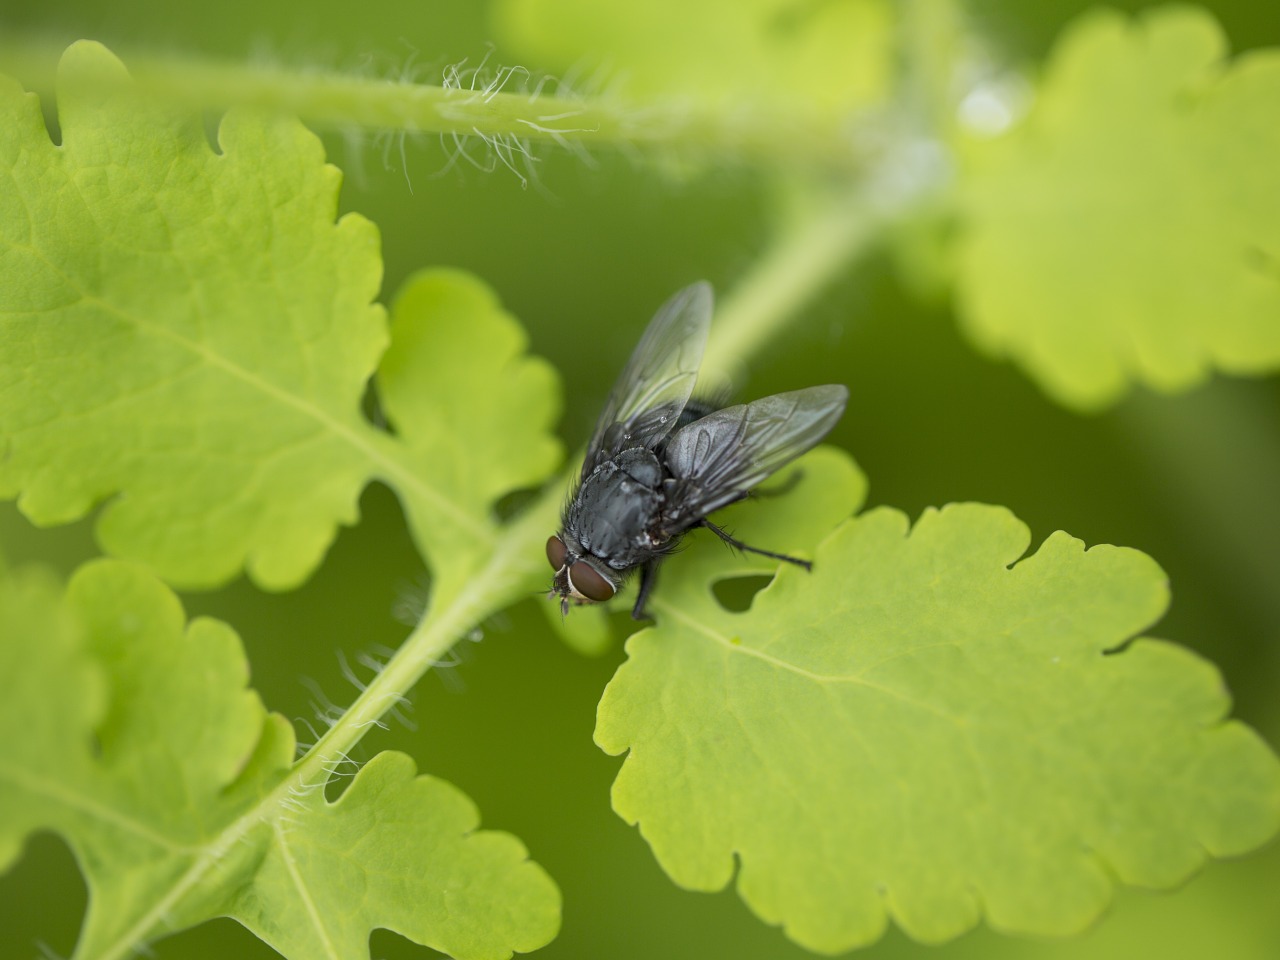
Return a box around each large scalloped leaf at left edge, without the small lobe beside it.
[0,42,387,588]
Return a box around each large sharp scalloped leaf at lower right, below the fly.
[596,450,1280,952]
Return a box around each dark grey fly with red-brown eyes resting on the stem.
[547,282,849,620]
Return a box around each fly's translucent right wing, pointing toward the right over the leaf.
[663,385,849,532]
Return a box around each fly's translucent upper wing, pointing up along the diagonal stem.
[582,282,712,480]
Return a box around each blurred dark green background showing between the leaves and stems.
[0,0,1280,960]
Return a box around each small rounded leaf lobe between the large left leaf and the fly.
[378,269,562,596]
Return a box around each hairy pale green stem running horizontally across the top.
[0,37,864,174]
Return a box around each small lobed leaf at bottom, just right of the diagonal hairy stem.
[232,753,559,960]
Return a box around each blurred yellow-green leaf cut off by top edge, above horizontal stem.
[493,0,893,115]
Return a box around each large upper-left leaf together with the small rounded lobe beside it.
[0,42,559,598]
